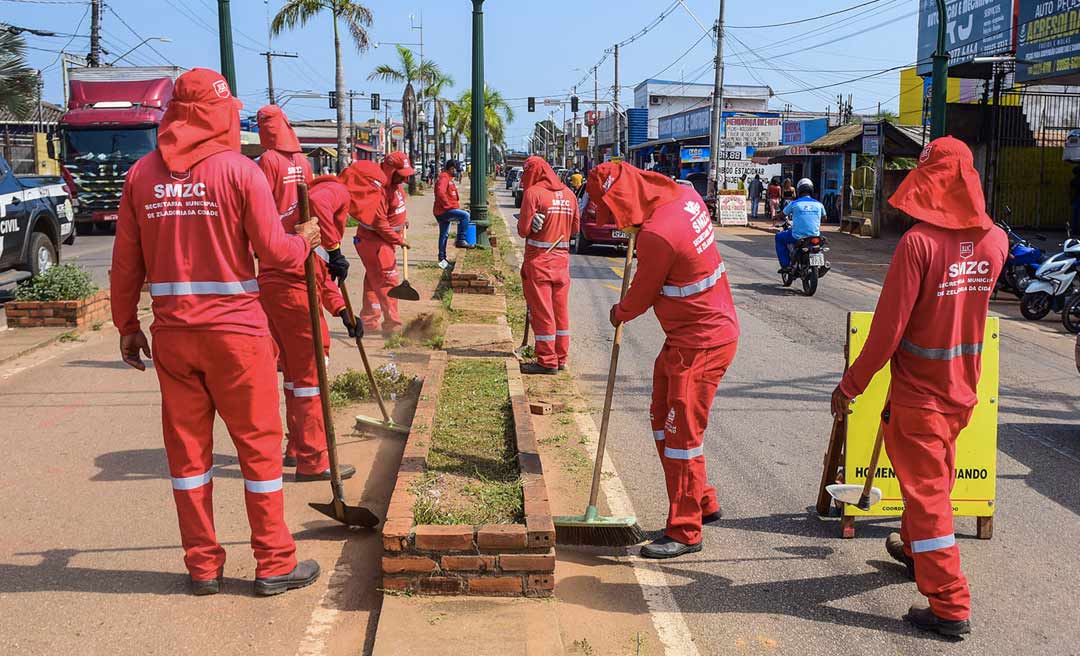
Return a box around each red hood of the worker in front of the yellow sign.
[889,136,994,230]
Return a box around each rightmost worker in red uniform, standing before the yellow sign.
[833,137,1009,635]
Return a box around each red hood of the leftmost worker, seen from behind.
[158,68,244,173]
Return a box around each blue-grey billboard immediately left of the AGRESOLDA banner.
[917,0,1015,76]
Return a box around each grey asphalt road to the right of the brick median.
[499,191,1080,655]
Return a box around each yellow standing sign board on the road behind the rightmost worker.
[843,312,1001,517]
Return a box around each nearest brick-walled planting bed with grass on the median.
[382,354,555,597]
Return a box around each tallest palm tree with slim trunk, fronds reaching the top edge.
[270,0,374,170]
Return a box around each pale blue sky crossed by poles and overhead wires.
[6,0,917,147]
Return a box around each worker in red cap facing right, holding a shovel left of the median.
[353,151,416,336]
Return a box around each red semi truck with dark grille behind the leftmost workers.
[58,66,184,235]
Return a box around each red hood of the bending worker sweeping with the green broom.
[585,162,683,228]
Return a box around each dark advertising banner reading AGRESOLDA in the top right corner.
[1016,0,1080,84]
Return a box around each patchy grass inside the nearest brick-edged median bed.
[413,358,525,524]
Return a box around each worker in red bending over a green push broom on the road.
[586,162,739,559]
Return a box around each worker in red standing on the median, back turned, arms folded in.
[517,156,580,374]
